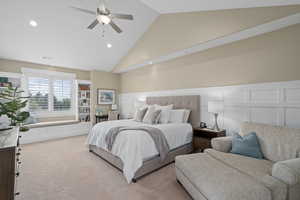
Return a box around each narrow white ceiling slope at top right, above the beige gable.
[141,0,300,13]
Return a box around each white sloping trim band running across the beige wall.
[115,13,300,73]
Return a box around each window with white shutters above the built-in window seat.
[24,69,75,117]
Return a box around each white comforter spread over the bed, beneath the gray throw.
[87,120,193,183]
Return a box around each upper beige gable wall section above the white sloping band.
[114,6,300,71]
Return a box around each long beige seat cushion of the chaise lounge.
[175,153,272,200]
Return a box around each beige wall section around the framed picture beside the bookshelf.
[91,71,121,122]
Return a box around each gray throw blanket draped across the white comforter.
[105,126,170,161]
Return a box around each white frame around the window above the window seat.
[22,68,77,118]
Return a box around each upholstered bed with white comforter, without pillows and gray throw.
[87,95,200,183]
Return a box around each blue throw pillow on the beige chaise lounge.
[231,132,263,159]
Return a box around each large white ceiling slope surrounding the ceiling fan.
[0,0,158,71]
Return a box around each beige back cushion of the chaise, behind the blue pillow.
[240,122,300,162]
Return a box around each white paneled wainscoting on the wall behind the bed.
[119,81,300,135]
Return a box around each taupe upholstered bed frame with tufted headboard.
[89,95,200,182]
